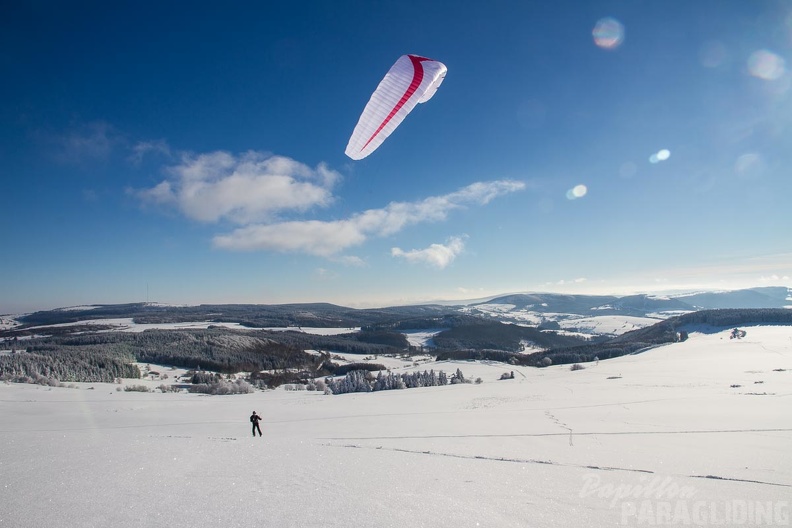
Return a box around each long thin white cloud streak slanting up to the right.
[213,180,525,257]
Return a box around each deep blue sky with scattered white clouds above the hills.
[0,0,792,313]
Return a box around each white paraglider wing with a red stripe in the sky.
[346,55,447,160]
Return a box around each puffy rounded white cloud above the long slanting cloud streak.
[138,151,341,225]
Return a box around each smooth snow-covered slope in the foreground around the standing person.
[0,326,792,528]
